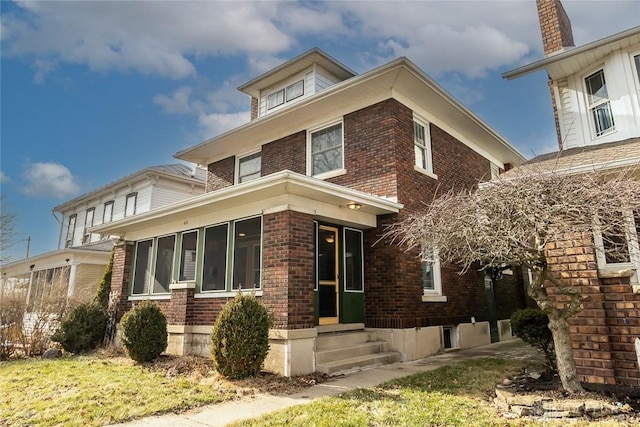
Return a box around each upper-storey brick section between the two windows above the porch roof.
[262,131,307,176]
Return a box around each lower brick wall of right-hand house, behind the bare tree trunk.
[547,234,640,386]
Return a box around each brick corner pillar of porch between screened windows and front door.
[262,211,315,329]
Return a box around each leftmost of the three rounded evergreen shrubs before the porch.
[51,303,107,353]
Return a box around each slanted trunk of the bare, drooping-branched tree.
[547,313,583,393]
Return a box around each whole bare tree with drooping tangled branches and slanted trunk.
[385,171,640,392]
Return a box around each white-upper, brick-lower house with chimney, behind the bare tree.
[504,0,640,386]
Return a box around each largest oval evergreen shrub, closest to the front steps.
[211,293,271,379]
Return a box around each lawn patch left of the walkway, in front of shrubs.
[0,356,235,426]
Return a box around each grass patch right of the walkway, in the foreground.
[233,358,625,427]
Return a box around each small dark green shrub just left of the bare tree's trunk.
[511,308,555,369]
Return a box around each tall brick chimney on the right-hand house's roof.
[536,0,575,56]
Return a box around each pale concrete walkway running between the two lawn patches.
[112,339,544,427]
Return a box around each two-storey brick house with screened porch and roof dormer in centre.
[93,49,525,375]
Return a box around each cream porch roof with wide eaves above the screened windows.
[90,170,403,244]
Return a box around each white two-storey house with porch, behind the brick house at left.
[0,164,206,307]
